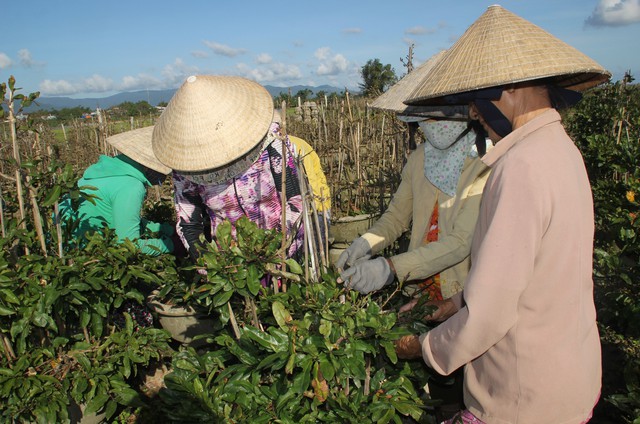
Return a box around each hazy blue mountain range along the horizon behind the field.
[25,85,344,113]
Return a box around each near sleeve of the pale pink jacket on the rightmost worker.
[420,161,548,375]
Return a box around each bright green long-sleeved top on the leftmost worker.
[61,155,174,255]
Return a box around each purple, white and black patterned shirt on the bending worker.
[173,124,303,258]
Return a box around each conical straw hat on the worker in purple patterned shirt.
[153,75,273,172]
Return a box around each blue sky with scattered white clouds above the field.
[0,0,640,98]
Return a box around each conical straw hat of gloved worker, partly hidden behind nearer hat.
[369,50,468,119]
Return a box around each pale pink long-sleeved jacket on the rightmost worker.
[420,110,601,424]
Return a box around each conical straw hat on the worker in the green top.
[107,126,171,175]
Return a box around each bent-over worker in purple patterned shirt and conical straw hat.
[153,75,303,259]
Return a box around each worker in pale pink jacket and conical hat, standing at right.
[397,6,610,424]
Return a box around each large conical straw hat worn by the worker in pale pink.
[406,5,611,105]
